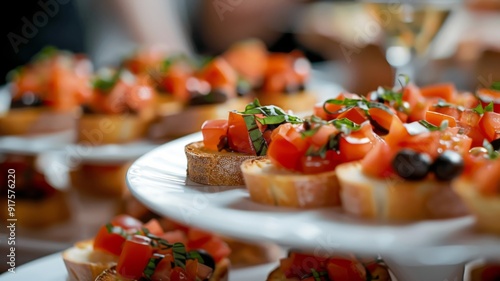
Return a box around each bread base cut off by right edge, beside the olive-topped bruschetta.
[453,178,500,235]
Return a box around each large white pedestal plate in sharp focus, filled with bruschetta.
[127,77,500,280]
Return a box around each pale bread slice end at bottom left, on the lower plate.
[62,240,118,281]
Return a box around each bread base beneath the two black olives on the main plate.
[336,162,467,221]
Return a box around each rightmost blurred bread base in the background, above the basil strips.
[257,91,318,113]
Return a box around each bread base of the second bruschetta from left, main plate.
[241,158,340,208]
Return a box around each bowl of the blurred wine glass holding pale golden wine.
[361,0,462,81]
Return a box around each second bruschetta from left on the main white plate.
[241,117,379,208]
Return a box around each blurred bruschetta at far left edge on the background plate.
[0,47,92,135]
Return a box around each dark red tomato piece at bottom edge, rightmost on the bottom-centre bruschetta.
[327,258,366,281]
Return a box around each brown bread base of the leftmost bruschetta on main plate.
[184,141,256,186]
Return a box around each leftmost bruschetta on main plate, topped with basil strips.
[185,100,302,186]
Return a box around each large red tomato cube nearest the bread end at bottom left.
[116,235,153,280]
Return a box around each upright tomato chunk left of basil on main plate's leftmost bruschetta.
[227,111,256,155]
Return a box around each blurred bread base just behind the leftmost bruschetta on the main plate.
[148,98,249,139]
